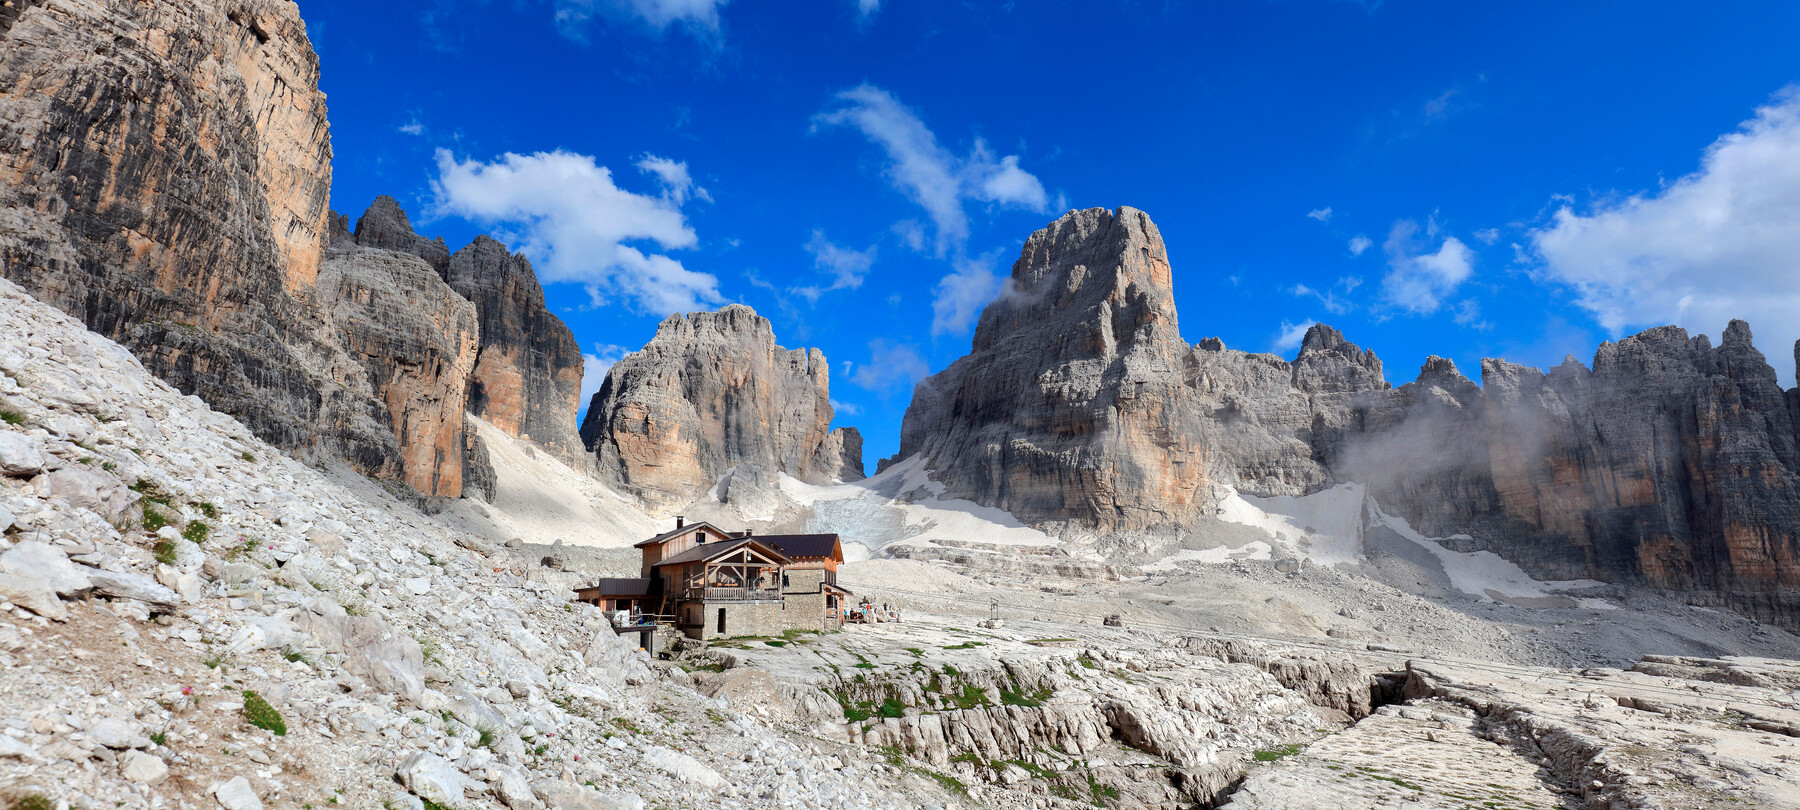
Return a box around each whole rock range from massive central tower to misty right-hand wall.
[900,209,1800,625]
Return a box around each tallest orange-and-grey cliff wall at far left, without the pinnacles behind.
[0,0,354,457]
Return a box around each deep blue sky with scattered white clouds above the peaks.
[304,0,1800,466]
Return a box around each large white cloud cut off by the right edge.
[1530,88,1800,380]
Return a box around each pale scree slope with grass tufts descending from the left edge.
[0,281,958,810]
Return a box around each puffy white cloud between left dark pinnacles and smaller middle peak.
[432,149,724,315]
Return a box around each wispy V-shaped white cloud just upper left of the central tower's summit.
[814,85,1049,254]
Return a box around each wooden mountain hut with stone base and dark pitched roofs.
[576,518,851,639]
